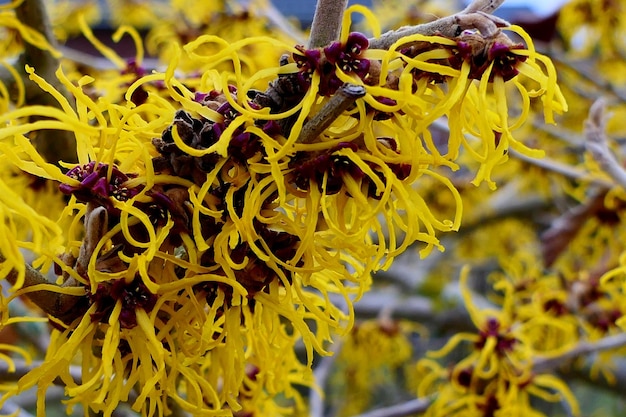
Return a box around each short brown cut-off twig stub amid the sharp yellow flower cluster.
[298,83,365,143]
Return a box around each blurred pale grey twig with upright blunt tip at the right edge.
[585,99,626,188]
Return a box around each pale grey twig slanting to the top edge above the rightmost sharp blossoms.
[370,0,509,49]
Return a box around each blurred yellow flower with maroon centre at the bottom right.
[417,268,580,416]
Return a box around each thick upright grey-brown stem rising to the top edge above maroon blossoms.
[308,0,348,49]
